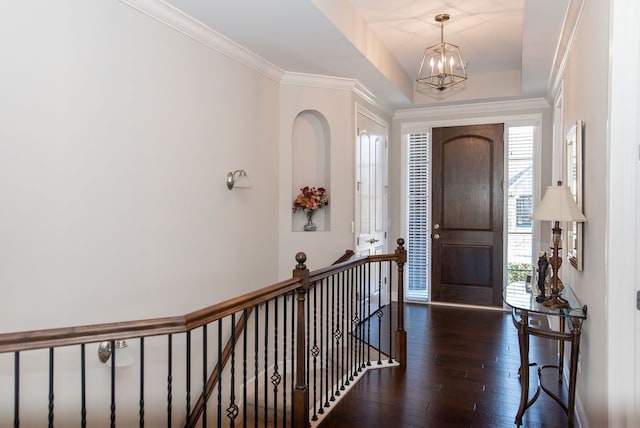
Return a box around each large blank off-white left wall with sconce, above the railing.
[0,0,280,331]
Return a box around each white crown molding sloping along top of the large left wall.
[120,0,283,82]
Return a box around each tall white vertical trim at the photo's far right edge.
[608,0,640,428]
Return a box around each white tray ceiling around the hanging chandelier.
[165,0,570,109]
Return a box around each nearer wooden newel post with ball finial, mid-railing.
[293,253,310,427]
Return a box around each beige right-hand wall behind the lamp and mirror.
[563,1,611,427]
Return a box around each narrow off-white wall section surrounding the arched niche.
[278,75,362,279]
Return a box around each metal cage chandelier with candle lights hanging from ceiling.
[416,13,467,91]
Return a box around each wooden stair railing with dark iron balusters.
[0,239,406,427]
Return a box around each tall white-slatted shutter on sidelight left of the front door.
[407,133,431,300]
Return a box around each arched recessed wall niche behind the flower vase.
[291,110,331,232]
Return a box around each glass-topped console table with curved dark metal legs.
[502,282,587,427]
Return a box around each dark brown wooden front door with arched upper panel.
[431,124,504,306]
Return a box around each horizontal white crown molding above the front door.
[393,98,549,119]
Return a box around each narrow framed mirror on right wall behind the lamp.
[565,120,583,270]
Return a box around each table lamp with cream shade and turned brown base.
[531,181,587,309]
